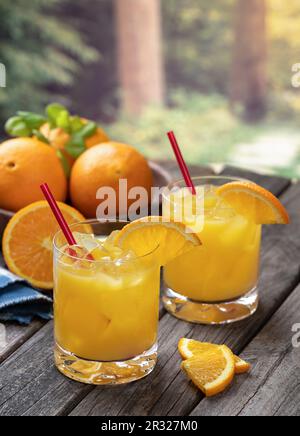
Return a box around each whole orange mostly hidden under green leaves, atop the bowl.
[40,119,109,167]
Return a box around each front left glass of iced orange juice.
[54,221,160,385]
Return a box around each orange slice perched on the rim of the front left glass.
[115,216,201,265]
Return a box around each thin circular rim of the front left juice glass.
[52,219,160,265]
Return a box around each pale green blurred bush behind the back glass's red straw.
[108,91,252,163]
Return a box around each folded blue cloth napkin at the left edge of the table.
[0,254,52,325]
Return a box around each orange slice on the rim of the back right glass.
[217,181,290,224]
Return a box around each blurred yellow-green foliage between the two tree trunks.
[161,0,235,94]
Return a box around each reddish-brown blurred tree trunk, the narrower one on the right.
[231,0,267,121]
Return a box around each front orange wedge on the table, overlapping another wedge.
[181,345,235,397]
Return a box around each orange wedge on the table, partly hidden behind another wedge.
[178,338,251,374]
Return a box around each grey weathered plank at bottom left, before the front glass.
[0,322,91,416]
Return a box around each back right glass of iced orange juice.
[163,176,261,324]
